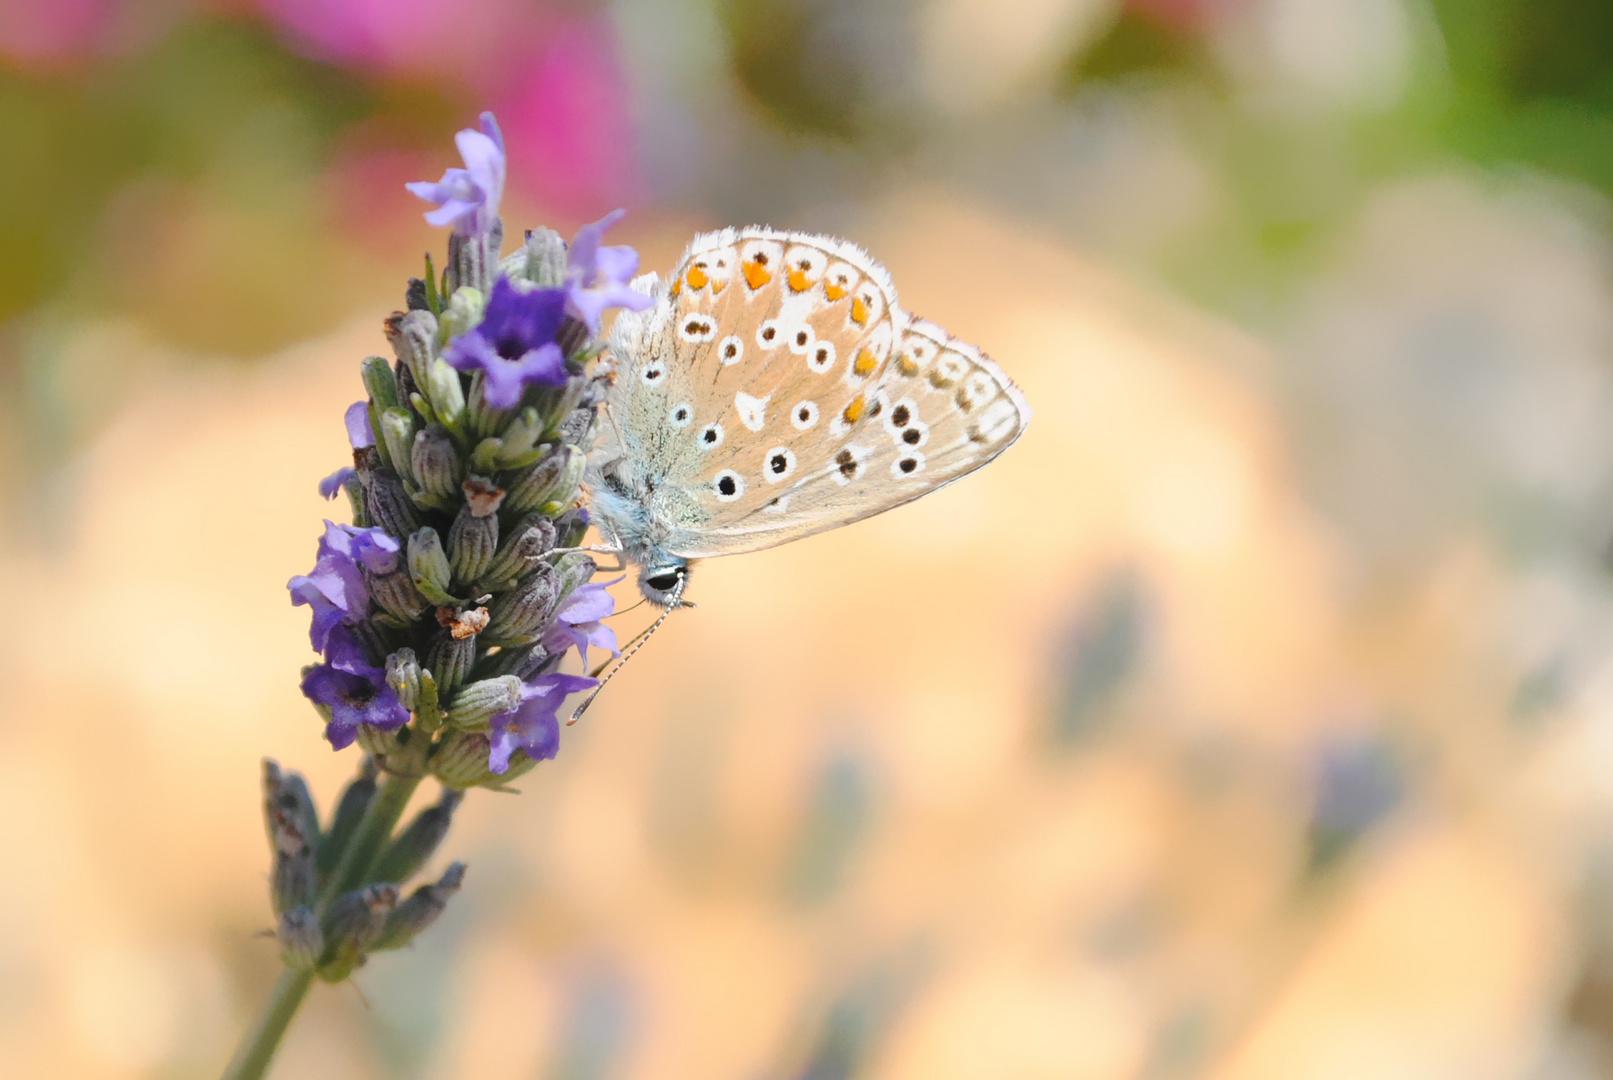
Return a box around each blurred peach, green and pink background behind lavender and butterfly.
[0,0,1613,1080]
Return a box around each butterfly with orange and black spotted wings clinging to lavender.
[589,227,1031,609]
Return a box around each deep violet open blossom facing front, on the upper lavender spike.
[442,277,566,409]
